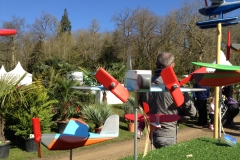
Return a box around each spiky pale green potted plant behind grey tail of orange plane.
[81,103,113,133]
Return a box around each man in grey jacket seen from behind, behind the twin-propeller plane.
[139,52,196,149]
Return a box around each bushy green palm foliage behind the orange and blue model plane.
[31,58,88,121]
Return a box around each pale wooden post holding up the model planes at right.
[213,23,222,139]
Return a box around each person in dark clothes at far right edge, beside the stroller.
[222,85,239,127]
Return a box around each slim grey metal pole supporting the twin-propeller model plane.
[134,92,139,160]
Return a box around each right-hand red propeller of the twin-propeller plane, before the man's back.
[161,66,184,107]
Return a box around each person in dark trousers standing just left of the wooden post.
[194,82,210,127]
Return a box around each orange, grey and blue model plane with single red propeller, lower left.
[32,115,119,160]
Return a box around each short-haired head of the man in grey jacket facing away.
[156,52,174,69]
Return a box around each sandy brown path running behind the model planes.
[34,115,240,160]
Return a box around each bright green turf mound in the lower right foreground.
[121,137,240,160]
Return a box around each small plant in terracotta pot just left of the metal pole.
[123,97,135,132]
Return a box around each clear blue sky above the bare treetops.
[0,0,239,31]
